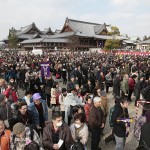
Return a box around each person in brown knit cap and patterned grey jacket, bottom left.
[10,123,43,150]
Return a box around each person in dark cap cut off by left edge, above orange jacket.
[0,94,11,121]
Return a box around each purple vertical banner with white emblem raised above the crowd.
[40,62,50,77]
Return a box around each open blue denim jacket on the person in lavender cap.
[29,99,48,125]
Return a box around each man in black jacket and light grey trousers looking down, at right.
[112,98,129,150]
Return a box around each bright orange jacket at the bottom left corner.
[0,130,11,150]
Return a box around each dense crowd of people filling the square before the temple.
[0,51,150,150]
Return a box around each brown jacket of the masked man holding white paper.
[43,121,73,150]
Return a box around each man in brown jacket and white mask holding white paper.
[43,112,73,150]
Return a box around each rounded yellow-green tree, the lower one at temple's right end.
[104,39,120,50]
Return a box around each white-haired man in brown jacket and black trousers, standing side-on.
[89,96,104,150]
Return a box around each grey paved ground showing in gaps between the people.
[19,82,141,150]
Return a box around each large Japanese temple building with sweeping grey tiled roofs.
[5,18,126,50]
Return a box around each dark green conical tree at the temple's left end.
[8,28,19,49]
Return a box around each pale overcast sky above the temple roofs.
[0,0,150,40]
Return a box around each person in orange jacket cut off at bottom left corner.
[0,120,11,150]
